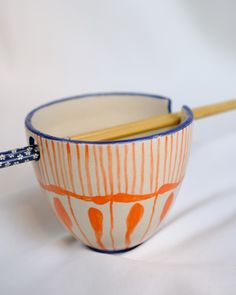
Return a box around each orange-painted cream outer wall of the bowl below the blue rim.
[28,125,192,250]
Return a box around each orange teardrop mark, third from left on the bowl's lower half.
[125,203,144,248]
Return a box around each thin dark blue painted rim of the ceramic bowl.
[25,92,193,144]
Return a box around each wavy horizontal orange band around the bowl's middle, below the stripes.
[40,182,180,204]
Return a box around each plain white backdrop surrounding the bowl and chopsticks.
[0,0,236,295]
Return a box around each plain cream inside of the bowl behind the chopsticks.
[31,94,170,141]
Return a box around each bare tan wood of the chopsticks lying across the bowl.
[69,99,236,141]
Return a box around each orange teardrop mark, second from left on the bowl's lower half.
[88,208,106,250]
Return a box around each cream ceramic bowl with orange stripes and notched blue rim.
[26,93,193,251]
